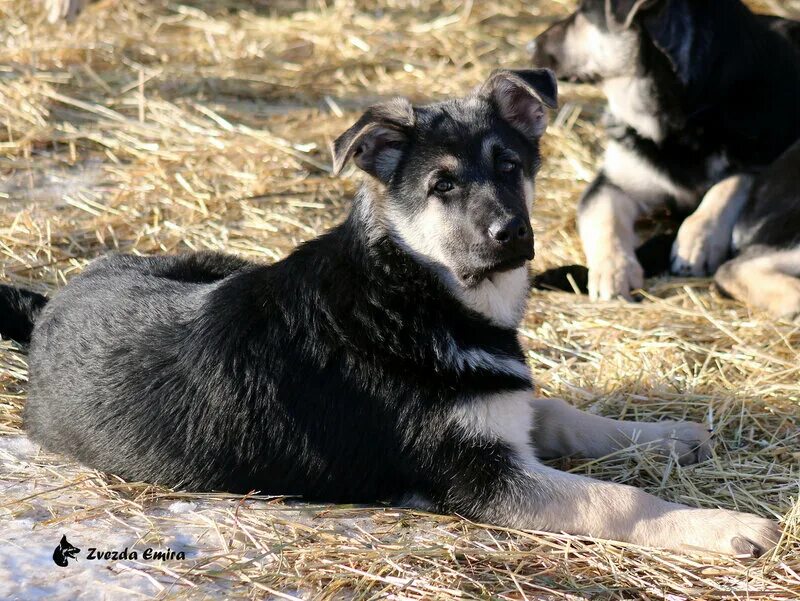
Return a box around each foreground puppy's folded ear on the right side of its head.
[480,69,558,138]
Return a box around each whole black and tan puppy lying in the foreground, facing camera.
[0,70,779,555]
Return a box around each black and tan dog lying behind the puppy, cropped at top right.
[534,0,800,315]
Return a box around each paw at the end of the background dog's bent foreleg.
[672,212,730,277]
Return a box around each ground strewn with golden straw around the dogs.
[0,0,800,600]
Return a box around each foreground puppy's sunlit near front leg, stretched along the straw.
[440,412,779,555]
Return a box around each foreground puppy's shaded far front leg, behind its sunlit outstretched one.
[532,399,711,464]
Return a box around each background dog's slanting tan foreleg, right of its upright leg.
[672,175,753,277]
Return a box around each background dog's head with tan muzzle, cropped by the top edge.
[530,0,708,83]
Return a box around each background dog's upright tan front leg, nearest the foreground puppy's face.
[578,172,644,300]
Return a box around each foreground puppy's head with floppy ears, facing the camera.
[334,70,557,287]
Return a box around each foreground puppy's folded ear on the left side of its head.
[333,98,414,183]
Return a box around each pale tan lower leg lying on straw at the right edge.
[715,247,800,319]
